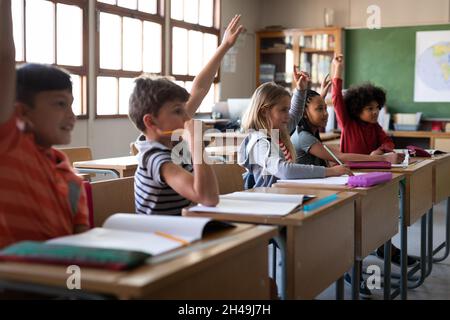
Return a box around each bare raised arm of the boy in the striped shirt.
[186,15,244,117]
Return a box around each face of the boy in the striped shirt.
[149,100,189,137]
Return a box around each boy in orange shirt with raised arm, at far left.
[0,0,88,248]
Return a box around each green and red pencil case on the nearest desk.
[0,241,150,270]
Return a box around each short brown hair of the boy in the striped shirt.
[128,76,190,132]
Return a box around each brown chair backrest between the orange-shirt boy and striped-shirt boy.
[91,177,136,227]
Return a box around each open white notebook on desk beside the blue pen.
[189,192,304,216]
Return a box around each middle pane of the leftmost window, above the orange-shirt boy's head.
[26,0,55,64]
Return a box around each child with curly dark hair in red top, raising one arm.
[332,55,400,155]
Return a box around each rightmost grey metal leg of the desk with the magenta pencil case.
[400,180,408,300]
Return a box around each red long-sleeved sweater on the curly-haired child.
[332,78,394,154]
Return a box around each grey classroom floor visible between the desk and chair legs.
[317,201,450,300]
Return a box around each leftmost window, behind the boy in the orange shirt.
[12,0,88,117]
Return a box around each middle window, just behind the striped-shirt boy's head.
[96,0,164,117]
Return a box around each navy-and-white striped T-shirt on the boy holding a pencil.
[134,136,193,215]
